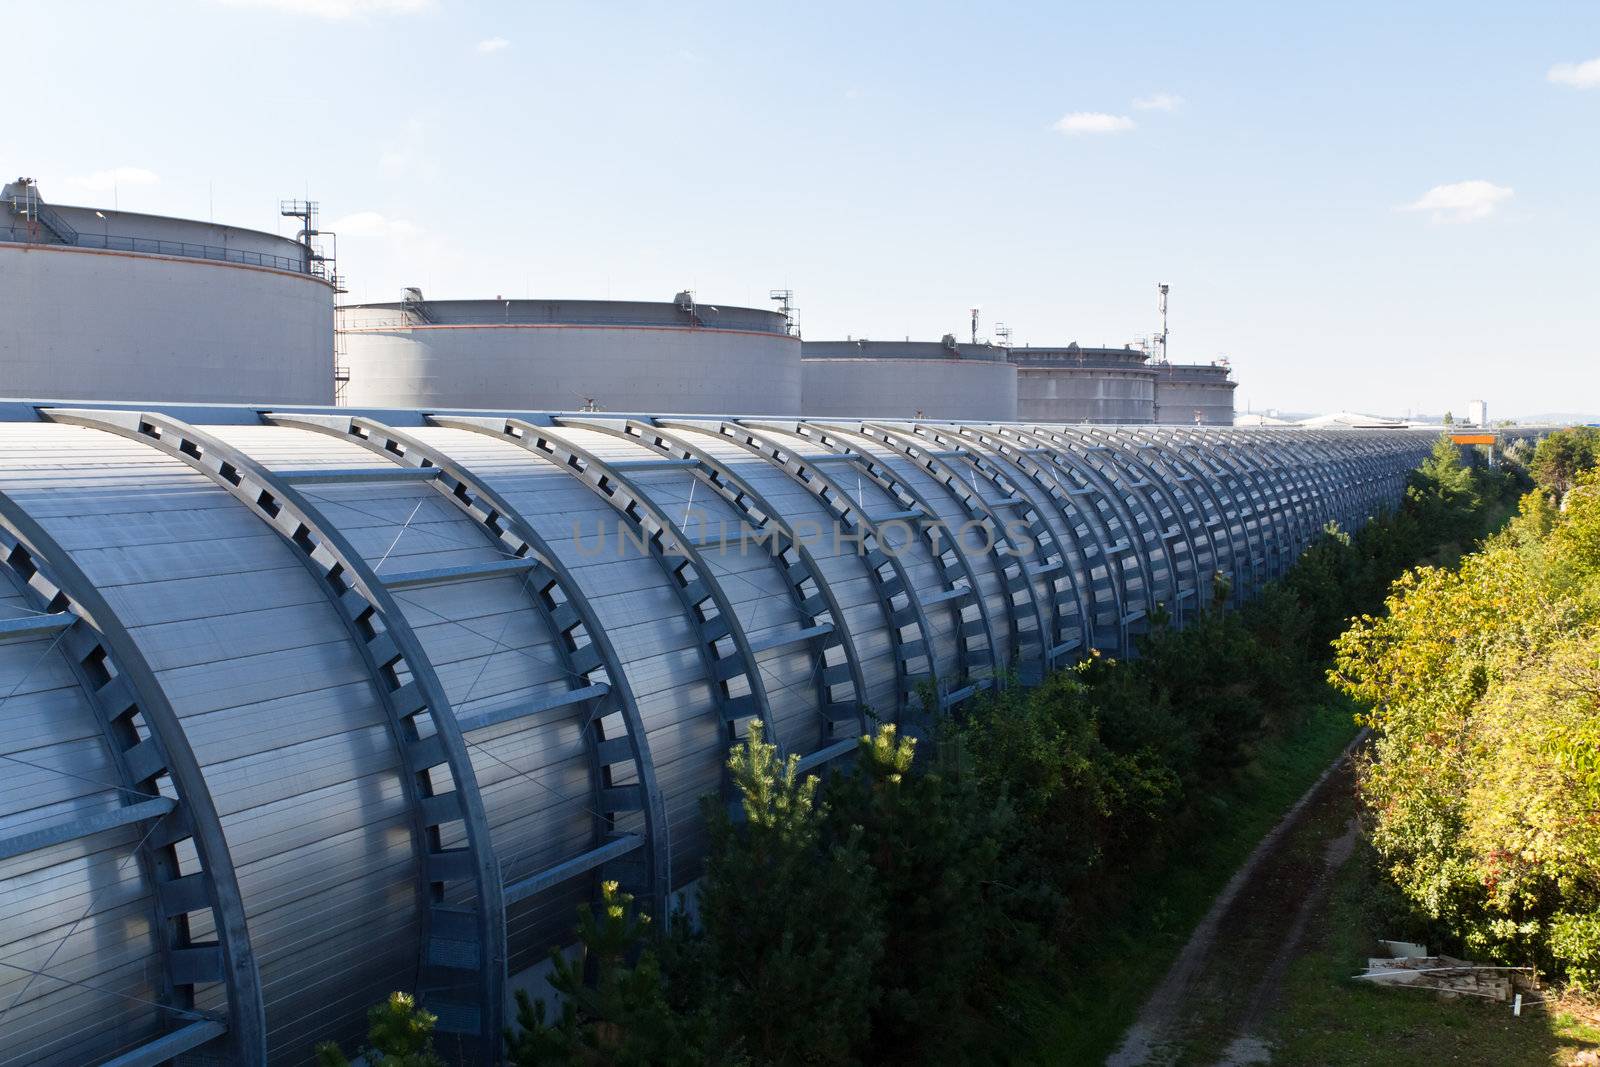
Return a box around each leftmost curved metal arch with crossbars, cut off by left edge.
[0,493,266,1067]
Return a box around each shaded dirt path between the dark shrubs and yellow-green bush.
[1106,731,1365,1067]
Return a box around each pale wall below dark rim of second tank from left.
[341,309,800,416]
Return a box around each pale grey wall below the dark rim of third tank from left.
[800,356,1018,422]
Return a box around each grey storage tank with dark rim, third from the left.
[800,338,1018,422]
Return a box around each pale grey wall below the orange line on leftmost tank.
[0,242,333,403]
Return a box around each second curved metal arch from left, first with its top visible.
[40,408,506,1062]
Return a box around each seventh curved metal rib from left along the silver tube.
[741,421,1002,712]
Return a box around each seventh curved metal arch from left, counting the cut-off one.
[741,421,1000,707]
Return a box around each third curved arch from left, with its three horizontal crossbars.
[262,411,669,915]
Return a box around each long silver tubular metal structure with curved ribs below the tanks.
[0,402,1432,1067]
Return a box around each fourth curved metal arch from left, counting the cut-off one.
[427,414,784,801]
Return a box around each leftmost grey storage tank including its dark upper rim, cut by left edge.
[0,181,334,405]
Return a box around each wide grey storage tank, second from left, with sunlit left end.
[339,290,800,414]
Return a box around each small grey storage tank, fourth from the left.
[1011,341,1155,424]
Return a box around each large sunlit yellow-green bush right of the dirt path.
[1331,470,1600,984]
